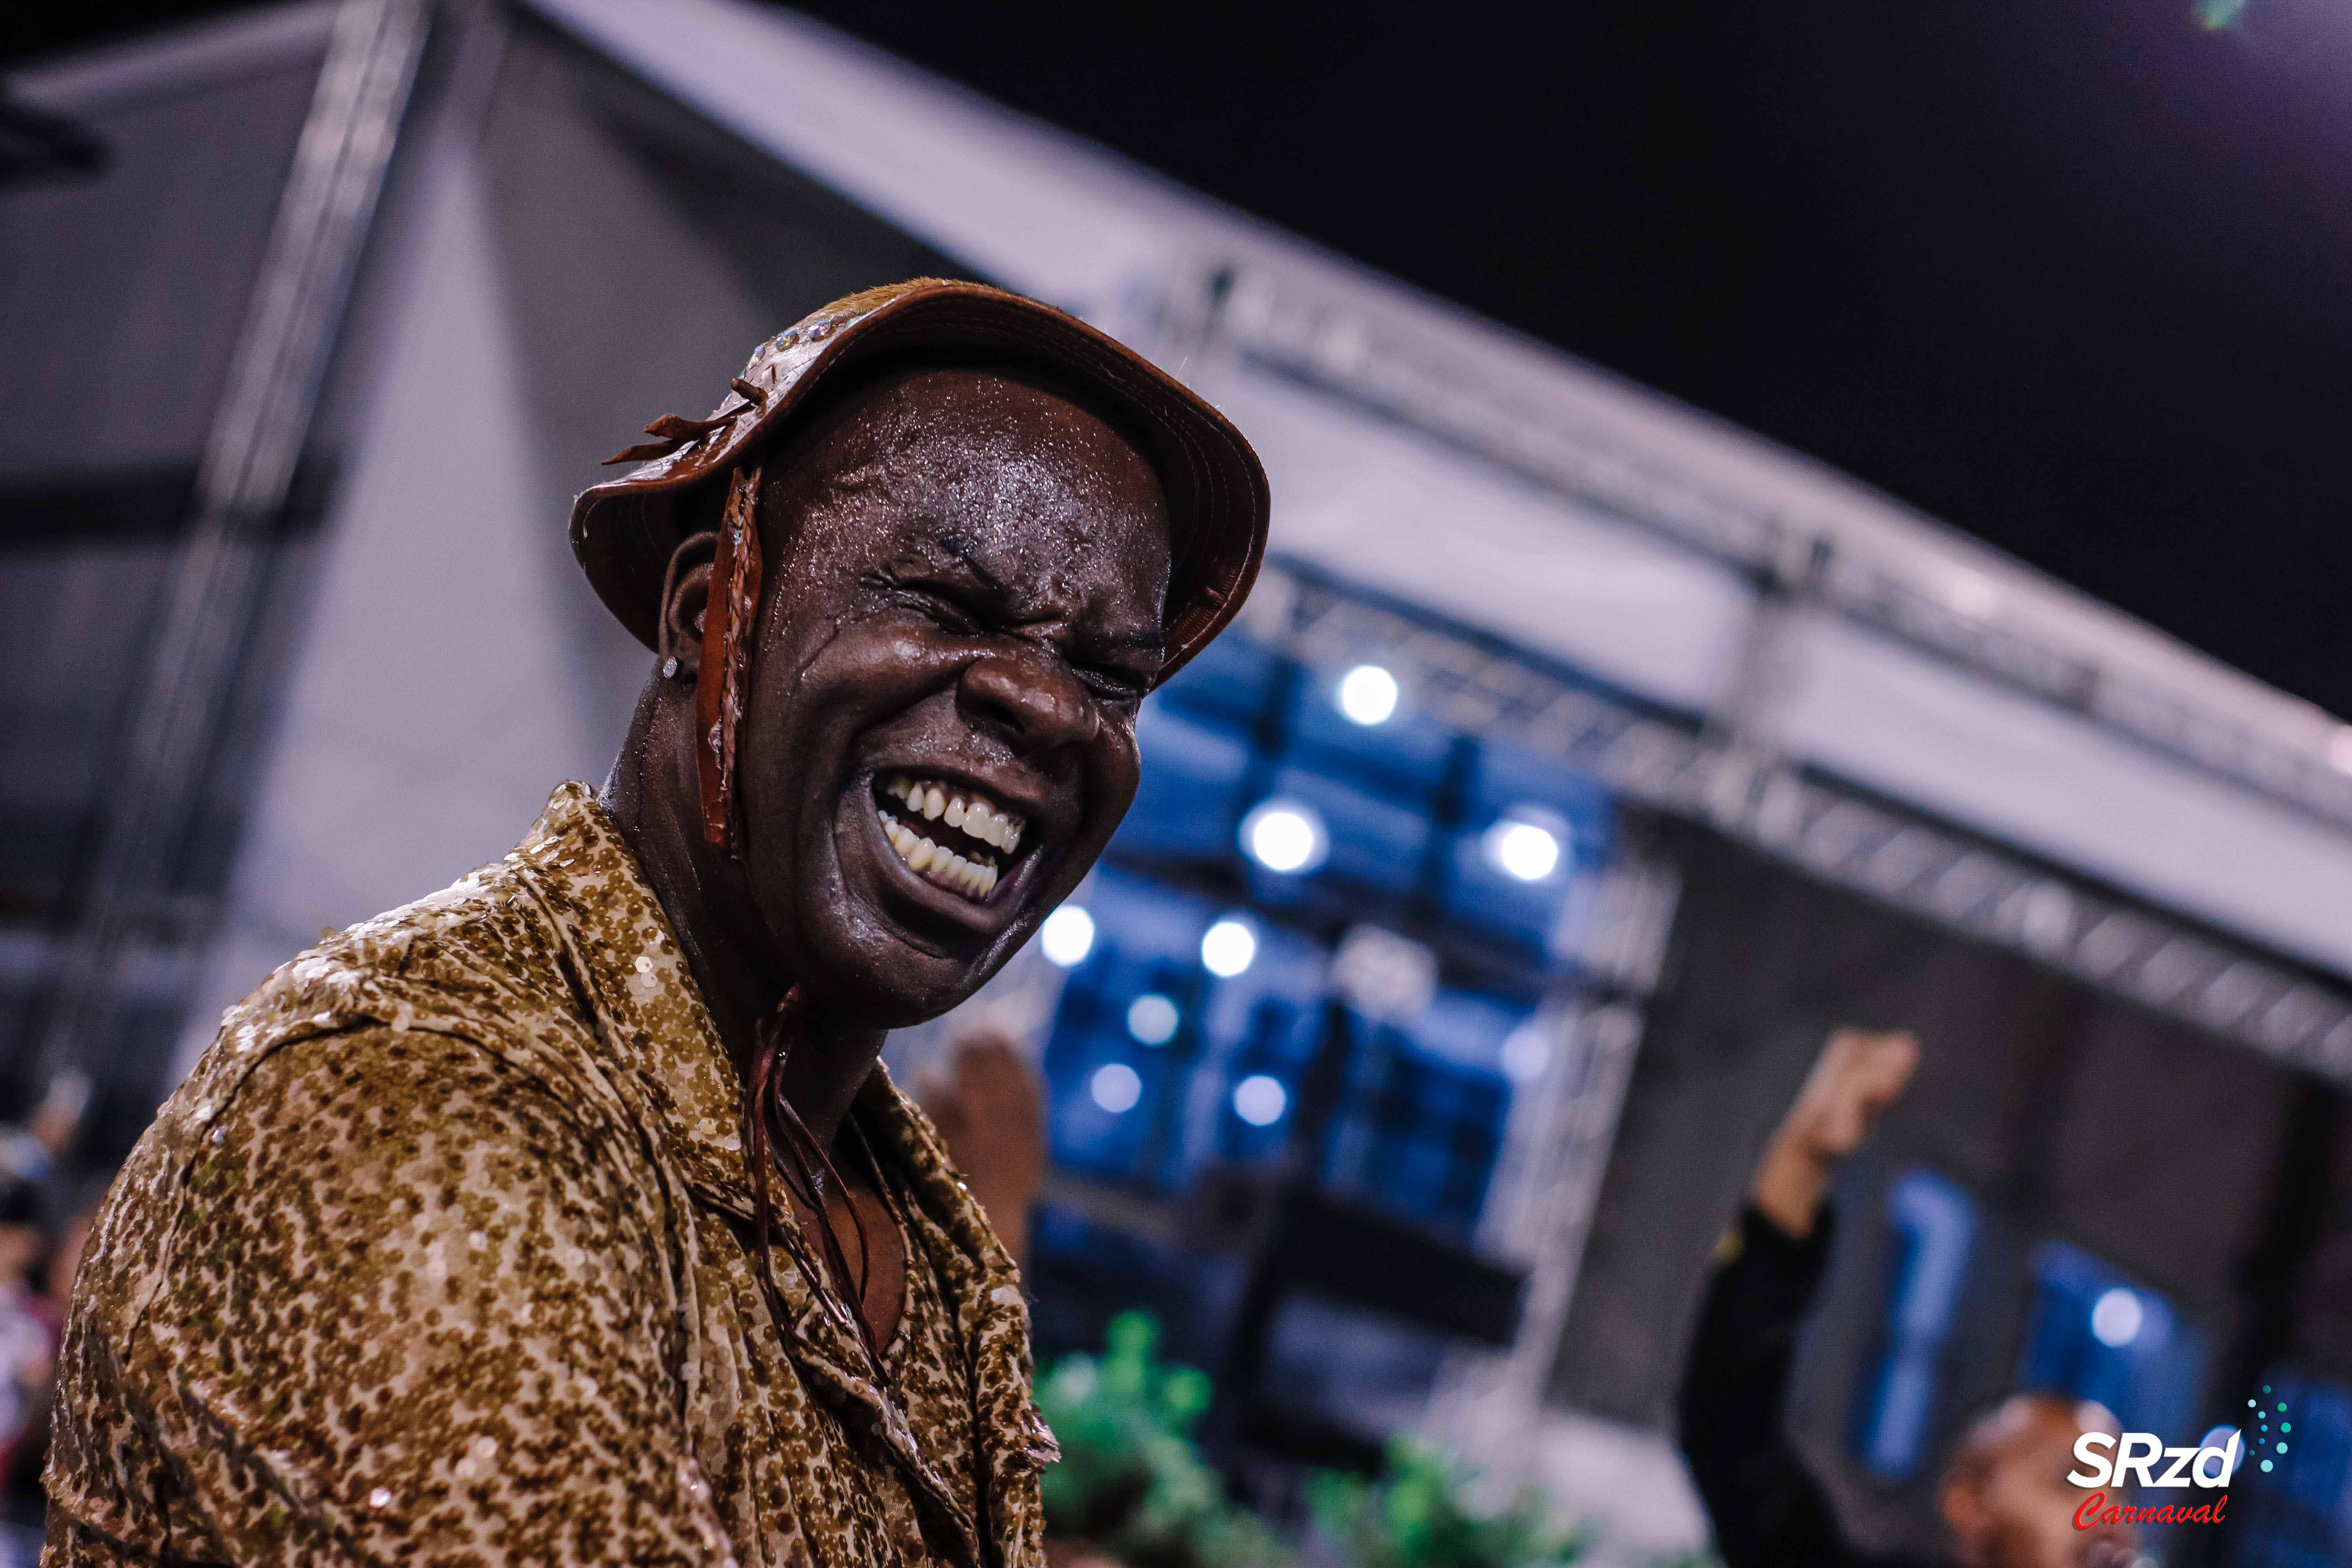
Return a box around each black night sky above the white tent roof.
[18,0,2352,715]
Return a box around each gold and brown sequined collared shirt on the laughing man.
[42,785,1054,1568]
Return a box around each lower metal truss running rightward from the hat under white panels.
[1270,566,2352,1086]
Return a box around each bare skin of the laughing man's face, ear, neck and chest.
[607,369,1169,1345]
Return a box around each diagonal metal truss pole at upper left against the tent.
[33,0,430,1100]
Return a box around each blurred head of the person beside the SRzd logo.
[1945,1403,2136,1568]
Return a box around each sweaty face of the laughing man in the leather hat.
[736,369,1169,1027]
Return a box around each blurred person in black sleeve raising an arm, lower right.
[1679,1030,2136,1568]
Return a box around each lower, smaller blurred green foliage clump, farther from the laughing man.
[1308,1436,1590,1568]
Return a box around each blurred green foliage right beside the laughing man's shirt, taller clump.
[1035,1312,1291,1568]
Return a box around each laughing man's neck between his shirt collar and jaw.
[604,682,884,1147]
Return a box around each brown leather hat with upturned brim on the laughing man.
[572,278,1268,679]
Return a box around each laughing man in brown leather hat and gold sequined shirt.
[47,280,1265,1568]
